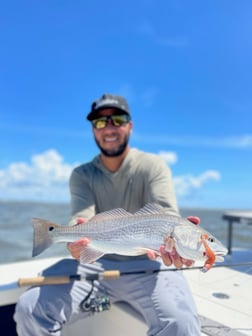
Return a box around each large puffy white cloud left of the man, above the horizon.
[0,149,77,201]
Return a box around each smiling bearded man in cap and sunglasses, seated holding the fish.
[15,94,200,336]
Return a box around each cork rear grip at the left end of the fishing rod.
[18,275,71,287]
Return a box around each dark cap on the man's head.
[87,94,130,121]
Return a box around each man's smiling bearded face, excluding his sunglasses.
[93,108,132,157]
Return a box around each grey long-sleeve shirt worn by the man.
[70,149,178,224]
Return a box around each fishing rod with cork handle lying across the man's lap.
[0,261,252,291]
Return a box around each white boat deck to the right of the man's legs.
[185,253,252,335]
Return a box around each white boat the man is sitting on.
[0,211,252,336]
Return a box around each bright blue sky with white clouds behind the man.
[0,0,252,209]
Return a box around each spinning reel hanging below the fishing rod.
[80,281,111,314]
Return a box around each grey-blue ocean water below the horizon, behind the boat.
[0,201,252,263]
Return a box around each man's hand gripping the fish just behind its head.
[147,216,200,268]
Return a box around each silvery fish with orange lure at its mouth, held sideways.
[32,204,228,271]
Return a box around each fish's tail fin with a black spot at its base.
[32,218,60,257]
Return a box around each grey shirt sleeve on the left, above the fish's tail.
[69,166,95,225]
